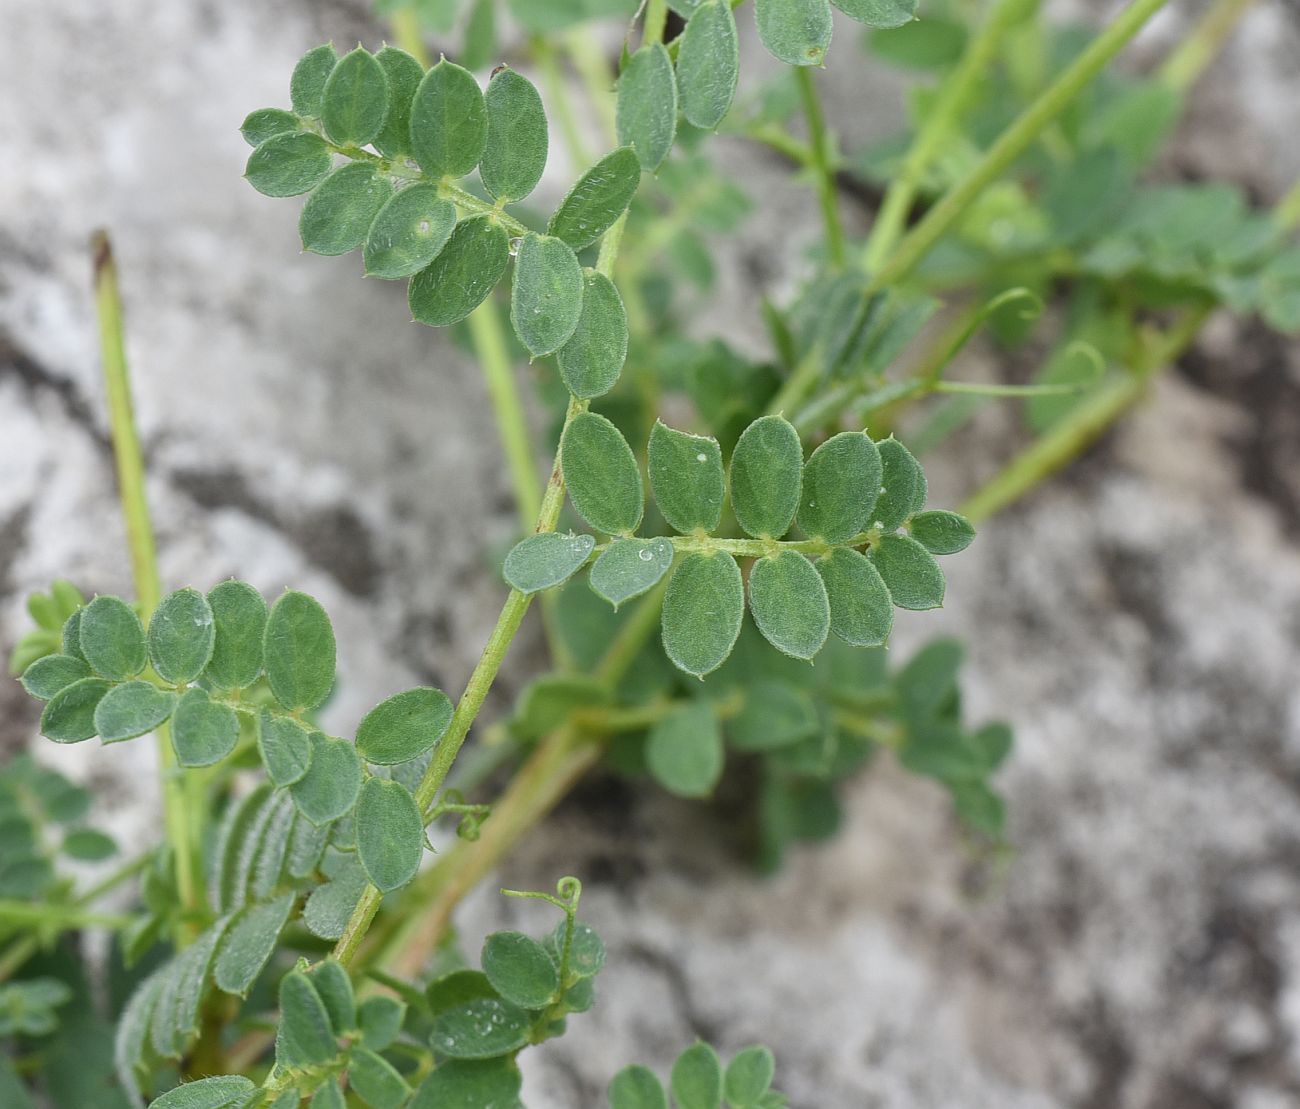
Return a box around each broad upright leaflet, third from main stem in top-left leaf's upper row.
[411,59,488,177]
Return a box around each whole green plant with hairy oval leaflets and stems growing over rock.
[0,0,1300,1109]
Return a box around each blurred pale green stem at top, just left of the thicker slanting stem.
[863,0,1024,273]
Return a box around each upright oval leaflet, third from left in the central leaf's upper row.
[731,416,803,540]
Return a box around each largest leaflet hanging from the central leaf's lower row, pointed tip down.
[662,551,745,677]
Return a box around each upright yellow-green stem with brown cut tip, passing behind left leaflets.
[91,231,203,945]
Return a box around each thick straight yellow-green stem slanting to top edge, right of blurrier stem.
[867,0,1169,295]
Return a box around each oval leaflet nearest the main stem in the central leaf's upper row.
[560,412,645,536]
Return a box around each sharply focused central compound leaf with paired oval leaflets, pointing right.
[503,412,974,677]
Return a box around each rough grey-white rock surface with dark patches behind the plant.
[0,0,1300,1109]
